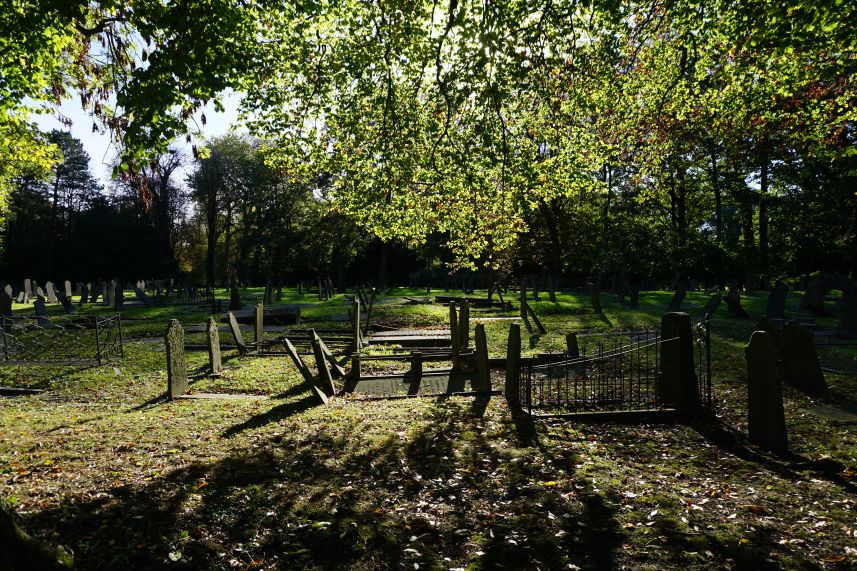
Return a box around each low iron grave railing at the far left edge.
[0,314,124,366]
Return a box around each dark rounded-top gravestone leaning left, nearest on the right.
[744,331,788,452]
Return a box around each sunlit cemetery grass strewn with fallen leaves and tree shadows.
[0,289,857,570]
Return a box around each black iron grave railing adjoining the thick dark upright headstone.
[518,321,711,416]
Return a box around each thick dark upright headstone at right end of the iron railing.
[658,312,699,408]
